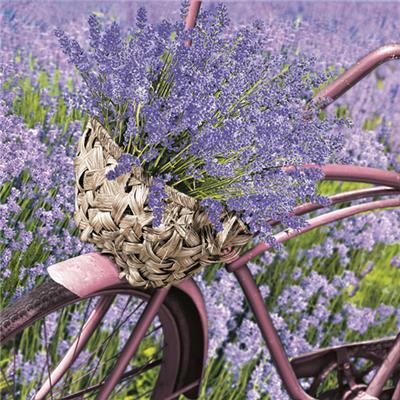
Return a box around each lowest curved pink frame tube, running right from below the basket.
[226,198,400,272]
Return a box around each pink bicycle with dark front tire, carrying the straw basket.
[0,2,400,400]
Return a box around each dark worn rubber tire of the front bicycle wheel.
[0,279,200,400]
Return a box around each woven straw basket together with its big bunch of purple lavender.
[56,4,341,287]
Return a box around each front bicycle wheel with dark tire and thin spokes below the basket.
[0,280,199,399]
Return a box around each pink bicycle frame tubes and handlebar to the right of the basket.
[226,44,400,400]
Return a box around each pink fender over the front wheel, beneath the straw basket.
[47,253,208,399]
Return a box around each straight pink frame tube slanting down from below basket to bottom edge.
[234,265,314,400]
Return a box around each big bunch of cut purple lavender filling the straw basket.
[56,5,341,241]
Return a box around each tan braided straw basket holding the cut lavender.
[74,118,251,288]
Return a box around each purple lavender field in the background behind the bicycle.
[0,0,400,400]
